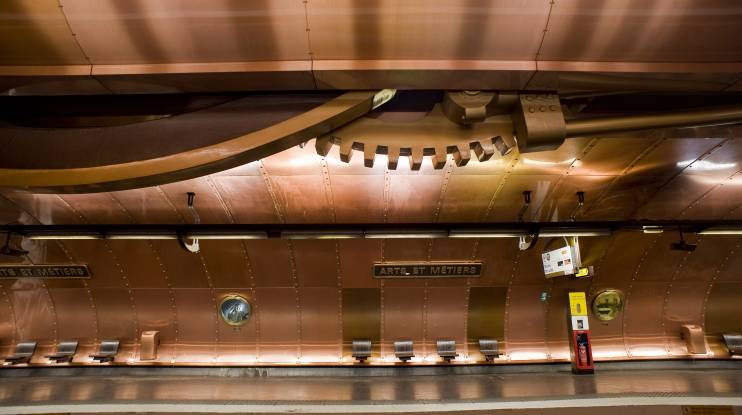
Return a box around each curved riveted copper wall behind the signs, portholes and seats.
[0,127,742,364]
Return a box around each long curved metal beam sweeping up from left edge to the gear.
[0,91,378,193]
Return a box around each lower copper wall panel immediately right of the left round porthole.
[255,287,301,363]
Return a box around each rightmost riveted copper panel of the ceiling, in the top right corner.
[539,0,742,62]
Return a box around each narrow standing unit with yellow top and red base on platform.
[569,292,595,373]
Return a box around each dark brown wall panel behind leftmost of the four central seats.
[343,288,381,355]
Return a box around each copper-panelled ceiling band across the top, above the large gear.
[0,0,742,94]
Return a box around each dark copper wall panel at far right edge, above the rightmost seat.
[705,283,742,335]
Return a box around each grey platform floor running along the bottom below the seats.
[0,362,742,415]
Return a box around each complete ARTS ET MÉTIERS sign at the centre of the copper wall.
[374,262,482,278]
